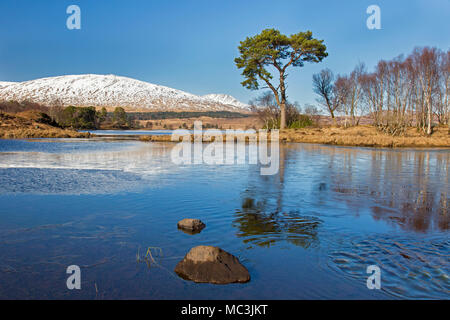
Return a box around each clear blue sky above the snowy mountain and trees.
[0,0,450,105]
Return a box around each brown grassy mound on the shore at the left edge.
[0,111,90,139]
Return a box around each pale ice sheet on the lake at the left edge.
[0,141,178,194]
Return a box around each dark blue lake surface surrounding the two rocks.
[0,139,450,299]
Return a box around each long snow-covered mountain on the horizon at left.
[0,74,248,111]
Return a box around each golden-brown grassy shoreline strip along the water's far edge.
[0,112,450,149]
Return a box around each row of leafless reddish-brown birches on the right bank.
[313,47,450,135]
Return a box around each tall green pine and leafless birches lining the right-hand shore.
[234,29,450,135]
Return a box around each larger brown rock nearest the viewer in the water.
[175,246,250,284]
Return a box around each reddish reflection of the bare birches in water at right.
[323,148,450,232]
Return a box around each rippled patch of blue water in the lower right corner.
[329,235,450,299]
